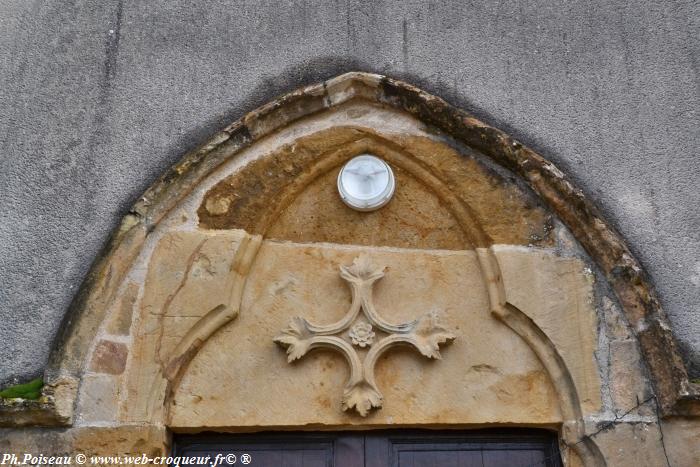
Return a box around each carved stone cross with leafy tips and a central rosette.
[274,255,456,417]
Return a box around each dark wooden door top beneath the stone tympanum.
[174,430,562,467]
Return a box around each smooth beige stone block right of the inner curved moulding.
[495,245,601,413]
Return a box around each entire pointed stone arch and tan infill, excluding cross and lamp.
[9,73,695,465]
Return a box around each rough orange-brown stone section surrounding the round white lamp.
[198,126,552,250]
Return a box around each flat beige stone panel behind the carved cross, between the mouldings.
[170,242,560,429]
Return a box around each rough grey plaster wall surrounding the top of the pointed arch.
[0,0,700,383]
